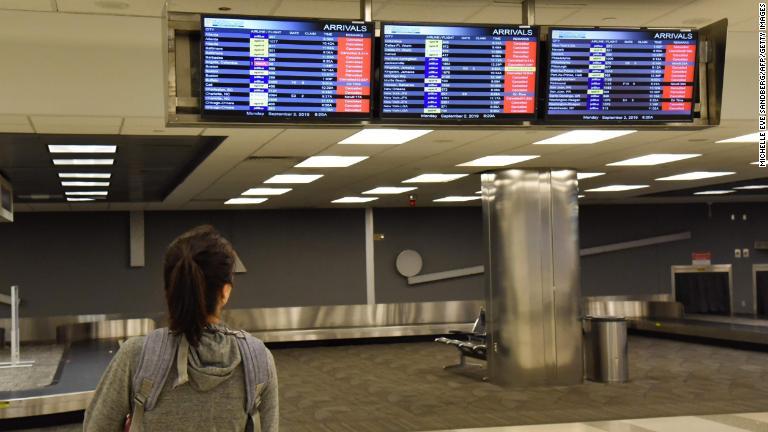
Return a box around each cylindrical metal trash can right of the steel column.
[584,316,629,383]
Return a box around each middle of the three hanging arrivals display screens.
[380,23,538,121]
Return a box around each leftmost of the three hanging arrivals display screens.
[201,17,373,122]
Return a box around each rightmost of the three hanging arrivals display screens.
[546,29,697,122]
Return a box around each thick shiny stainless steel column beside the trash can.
[482,169,583,386]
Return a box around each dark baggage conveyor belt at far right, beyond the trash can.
[629,316,768,346]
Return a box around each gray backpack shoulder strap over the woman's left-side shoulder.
[131,328,179,426]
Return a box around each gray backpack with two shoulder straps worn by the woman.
[125,328,270,432]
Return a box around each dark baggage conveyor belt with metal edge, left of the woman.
[0,340,118,419]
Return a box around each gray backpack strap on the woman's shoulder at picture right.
[235,330,270,416]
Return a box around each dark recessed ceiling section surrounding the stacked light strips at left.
[0,134,222,205]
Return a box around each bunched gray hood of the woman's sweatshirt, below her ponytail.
[176,324,241,391]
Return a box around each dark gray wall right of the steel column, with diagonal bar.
[579,203,768,313]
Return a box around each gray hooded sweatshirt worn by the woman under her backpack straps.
[83,331,279,432]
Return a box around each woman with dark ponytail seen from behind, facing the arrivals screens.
[83,226,278,432]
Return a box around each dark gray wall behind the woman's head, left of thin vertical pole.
[0,210,365,316]
